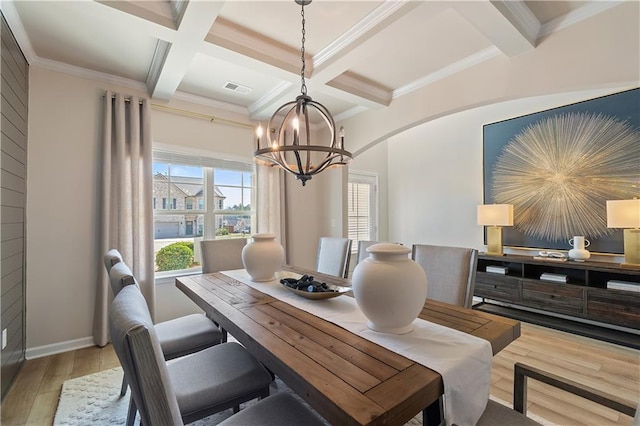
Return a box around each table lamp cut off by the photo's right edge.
[607,198,640,266]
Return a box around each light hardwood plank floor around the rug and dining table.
[1,323,640,426]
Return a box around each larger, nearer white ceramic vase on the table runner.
[351,243,427,334]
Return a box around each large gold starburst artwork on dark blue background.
[483,88,640,253]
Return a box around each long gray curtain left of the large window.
[93,91,155,346]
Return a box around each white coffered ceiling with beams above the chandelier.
[2,0,620,120]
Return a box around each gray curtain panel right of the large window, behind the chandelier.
[256,165,289,262]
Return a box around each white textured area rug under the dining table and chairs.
[53,367,553,426]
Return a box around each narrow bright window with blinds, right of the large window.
[347,172,378,252]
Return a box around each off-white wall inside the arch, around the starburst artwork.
[388,87,626,260]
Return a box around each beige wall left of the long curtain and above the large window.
[26,66,262,356]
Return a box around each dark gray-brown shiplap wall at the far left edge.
[0,11,29,398]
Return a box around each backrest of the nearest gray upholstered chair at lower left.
[109,285,183,425]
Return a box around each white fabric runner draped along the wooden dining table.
[223,269,493,426]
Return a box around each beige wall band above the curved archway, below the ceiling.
[337,1,640,154]
